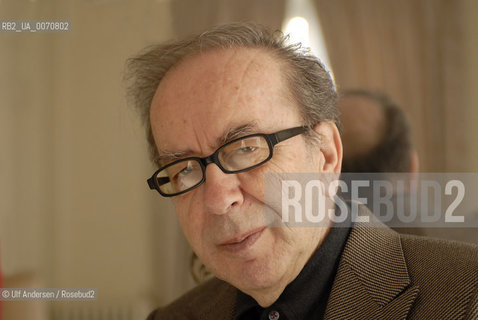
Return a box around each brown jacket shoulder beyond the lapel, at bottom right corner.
[400,235,478,319]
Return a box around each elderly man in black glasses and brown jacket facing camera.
[128,24,478,319]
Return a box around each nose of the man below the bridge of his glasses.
[204,163,244,214]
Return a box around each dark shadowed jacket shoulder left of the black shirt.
[147,278,237,320]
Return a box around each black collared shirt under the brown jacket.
[233,221,351,320]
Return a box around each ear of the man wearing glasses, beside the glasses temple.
[314,121,343,173]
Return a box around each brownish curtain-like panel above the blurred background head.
[316,0,478,172]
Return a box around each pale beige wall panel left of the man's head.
[0,0,192,316]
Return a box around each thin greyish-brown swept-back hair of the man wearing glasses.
[125,23,340,162]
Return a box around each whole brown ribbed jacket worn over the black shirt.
[148,208,478,320]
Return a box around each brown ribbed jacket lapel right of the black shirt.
[325,206,418,319]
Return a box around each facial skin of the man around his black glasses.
[151,49,334,300]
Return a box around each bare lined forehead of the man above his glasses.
[150,49,296,154]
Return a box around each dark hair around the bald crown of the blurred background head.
[340,89,412,173]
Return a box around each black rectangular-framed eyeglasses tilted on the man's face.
[147,127,309,197]
